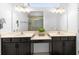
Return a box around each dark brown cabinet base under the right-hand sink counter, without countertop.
[51,36,76,55]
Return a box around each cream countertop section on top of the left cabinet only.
[0,31,35,38]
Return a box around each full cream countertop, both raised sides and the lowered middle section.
[0,31,76,40]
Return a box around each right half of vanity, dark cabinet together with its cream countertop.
[49,32,76,55]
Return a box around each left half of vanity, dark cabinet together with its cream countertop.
[1,32,33,55]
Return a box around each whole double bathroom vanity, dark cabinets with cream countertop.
[1,31,76,55]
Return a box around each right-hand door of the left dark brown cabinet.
[18,42,31,55]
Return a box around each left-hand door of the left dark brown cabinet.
[2,43,16,55]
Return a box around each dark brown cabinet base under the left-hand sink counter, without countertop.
[1,38,31,55]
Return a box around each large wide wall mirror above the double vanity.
[13,3,67,31]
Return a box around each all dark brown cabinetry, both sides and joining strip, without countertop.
[1,36,76,55]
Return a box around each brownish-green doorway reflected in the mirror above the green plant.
[28,11,43,31]
